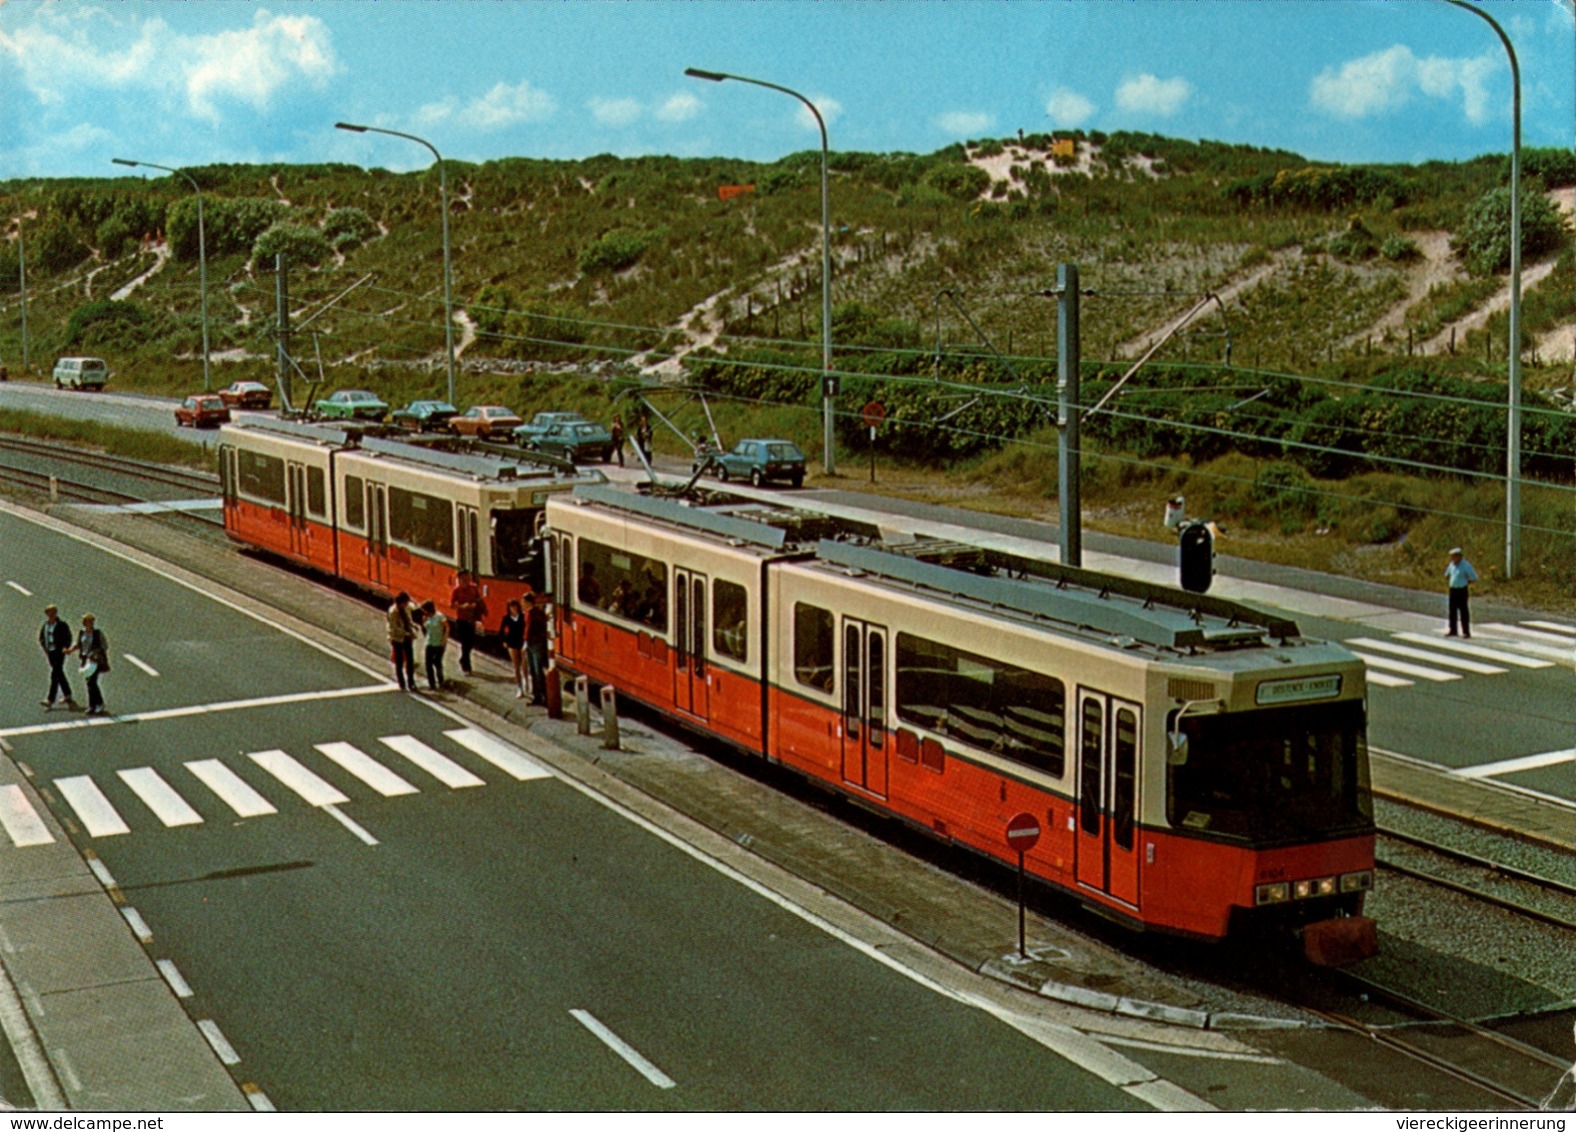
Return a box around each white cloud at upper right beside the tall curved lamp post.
[1308,44,1500,126]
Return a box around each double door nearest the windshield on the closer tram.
[1078,687,1143,908]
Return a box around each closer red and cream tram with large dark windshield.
[547,487,1374,954]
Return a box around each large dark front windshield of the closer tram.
[1166,700,1373,843]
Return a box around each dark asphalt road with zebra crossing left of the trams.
[0,516,1143,1110]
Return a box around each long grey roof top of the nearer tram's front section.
[816,539,1300,651]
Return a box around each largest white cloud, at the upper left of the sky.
[0,5,340,121]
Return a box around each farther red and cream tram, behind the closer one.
[219,418,602,631]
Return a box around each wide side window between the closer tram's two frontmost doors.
[897,632,1067,777]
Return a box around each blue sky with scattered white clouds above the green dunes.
[0,0,1576,178]
